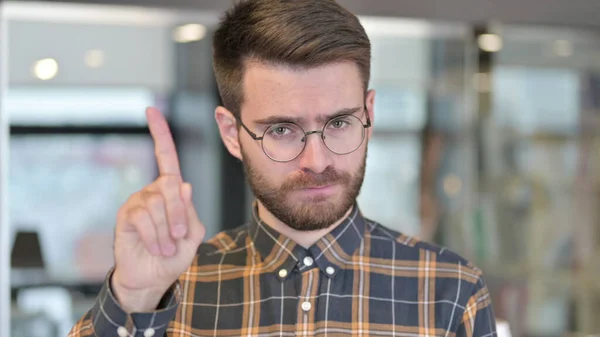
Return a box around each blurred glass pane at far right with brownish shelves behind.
[477,26,600,336]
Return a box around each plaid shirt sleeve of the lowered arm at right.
[456,277,496,337]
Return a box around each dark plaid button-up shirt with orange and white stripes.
[69,202,496,337]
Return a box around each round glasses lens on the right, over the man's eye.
[324,115,365,154]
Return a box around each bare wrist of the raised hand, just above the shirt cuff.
[110,270,168,313]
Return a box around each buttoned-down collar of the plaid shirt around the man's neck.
[249,202,366,279]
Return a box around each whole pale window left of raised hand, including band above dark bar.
[6,85,164,287]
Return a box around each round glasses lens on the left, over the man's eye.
[262,123,305,161]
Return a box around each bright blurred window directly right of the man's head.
[358,17,470,241]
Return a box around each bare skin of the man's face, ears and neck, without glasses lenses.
[215,62,375,247]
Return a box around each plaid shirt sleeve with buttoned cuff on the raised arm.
[68,270,181,337]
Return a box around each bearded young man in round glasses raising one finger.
[70,0,495,337]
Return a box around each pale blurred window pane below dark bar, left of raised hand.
[10,135,156,286]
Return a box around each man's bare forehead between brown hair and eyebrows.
[242,62,364,119]
